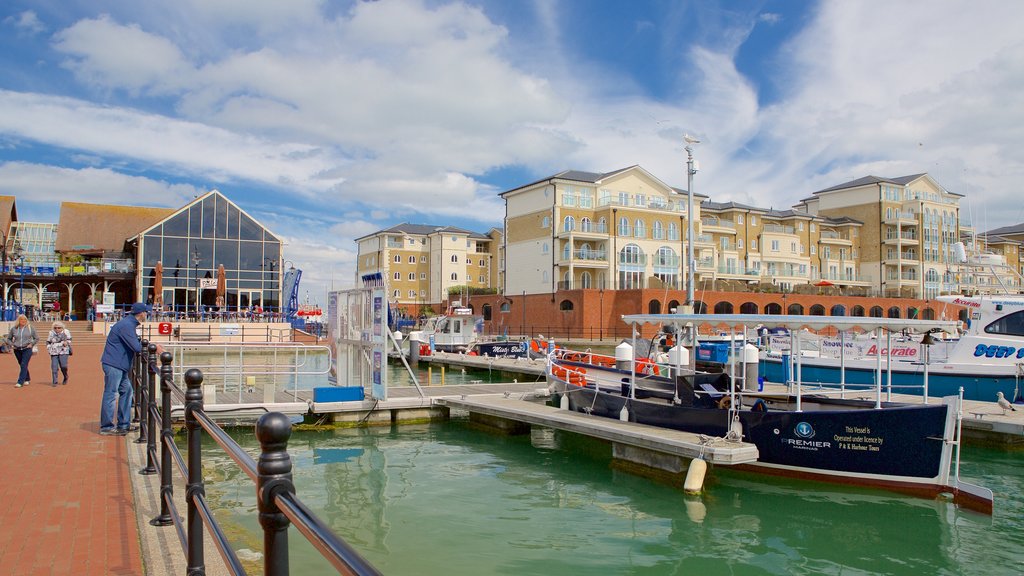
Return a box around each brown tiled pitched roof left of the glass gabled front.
[56,202,174,253]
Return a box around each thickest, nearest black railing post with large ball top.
[256,412,295,576]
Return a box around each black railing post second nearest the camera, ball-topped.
[185,368,206,576]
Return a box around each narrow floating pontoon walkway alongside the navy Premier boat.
[434,395,758,465]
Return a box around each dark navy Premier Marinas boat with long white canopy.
[548,315,992,513]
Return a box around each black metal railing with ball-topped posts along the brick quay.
[133,340,380,576]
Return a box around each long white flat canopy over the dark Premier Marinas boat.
[623,314,957,334]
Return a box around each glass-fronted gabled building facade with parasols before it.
[135,191,282,312]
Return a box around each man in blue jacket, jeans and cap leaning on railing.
[99,302,150,436]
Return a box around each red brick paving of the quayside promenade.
[0,338,143,576]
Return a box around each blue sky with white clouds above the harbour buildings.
[0,0,1024,303]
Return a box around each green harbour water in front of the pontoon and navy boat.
[199,419,1024,576]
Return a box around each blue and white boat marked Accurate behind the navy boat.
[760,294,1024,402]
